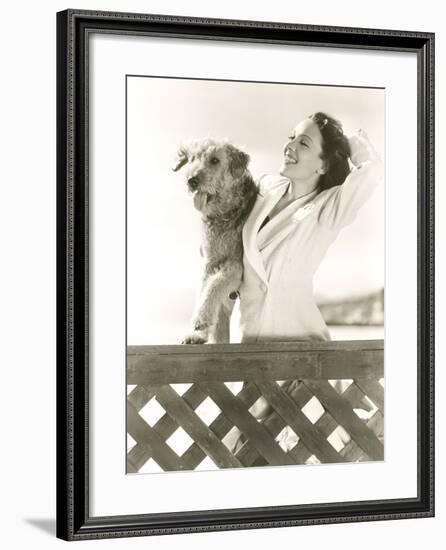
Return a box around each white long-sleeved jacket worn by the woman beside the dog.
[235,159,383,343]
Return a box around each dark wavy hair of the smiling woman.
[310,113,351,192]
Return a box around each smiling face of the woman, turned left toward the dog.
[280,118,324,180]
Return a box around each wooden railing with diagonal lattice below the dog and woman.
[127,340,384,473]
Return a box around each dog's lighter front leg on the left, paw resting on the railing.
[183,262,242,344]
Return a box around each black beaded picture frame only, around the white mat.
[57,10,434,540]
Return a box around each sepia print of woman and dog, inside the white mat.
[127,74,386,474]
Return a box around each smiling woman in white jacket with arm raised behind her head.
[229,113,383,458]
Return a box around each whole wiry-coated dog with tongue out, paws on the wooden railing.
[173,139,258,344]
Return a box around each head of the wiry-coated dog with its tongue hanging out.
[173,139,249,214]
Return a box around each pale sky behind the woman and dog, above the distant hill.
[127,76,385,344]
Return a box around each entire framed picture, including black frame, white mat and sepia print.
[57,10,434,540]
